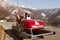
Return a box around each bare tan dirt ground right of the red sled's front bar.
[44,26,60,40]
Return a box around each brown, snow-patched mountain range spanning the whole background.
[0,1,60,24]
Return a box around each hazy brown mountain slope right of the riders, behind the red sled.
[23,8,60,26]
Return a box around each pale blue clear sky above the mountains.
[9,0,60,9]
